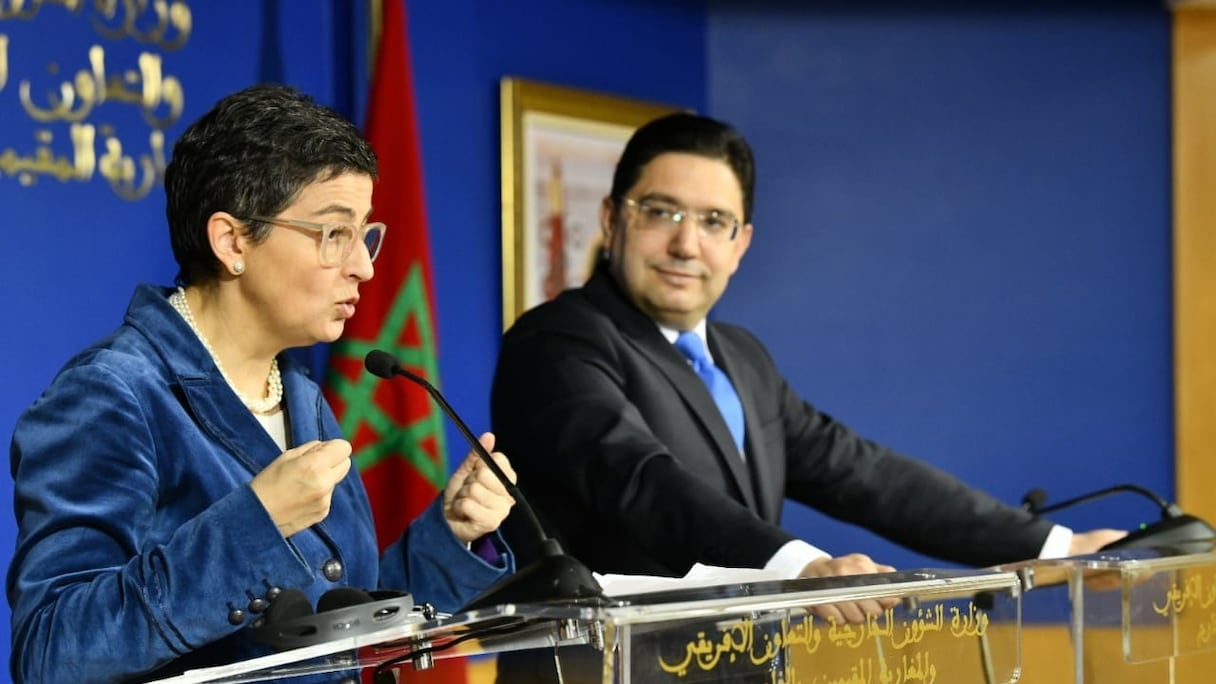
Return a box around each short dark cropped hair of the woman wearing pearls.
[164,85,377,285]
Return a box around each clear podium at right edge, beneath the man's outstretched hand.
[1000,542,1216,684]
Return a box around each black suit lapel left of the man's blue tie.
[585,268,760,511]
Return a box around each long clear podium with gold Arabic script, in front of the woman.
[149,570,1026,684]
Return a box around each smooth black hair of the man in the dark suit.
[612,113,755,217]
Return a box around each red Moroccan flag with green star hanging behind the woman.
[325,0,447,550]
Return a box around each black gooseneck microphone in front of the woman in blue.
[364,349,603,612]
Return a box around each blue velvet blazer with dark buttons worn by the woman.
[7,285,513,683]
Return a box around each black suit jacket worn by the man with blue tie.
[491,265,1051,576]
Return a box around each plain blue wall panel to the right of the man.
[708,2,1173,567]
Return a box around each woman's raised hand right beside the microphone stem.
[444,432,516,544]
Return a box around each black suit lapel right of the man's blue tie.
[706,324,781,522]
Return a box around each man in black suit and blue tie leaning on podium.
[491,114,1124,591]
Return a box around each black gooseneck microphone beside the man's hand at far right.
[1021,484,1216,554]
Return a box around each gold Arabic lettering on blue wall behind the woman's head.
[0,0,192,201]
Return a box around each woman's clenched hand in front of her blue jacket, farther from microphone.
[249,439,350,538]
